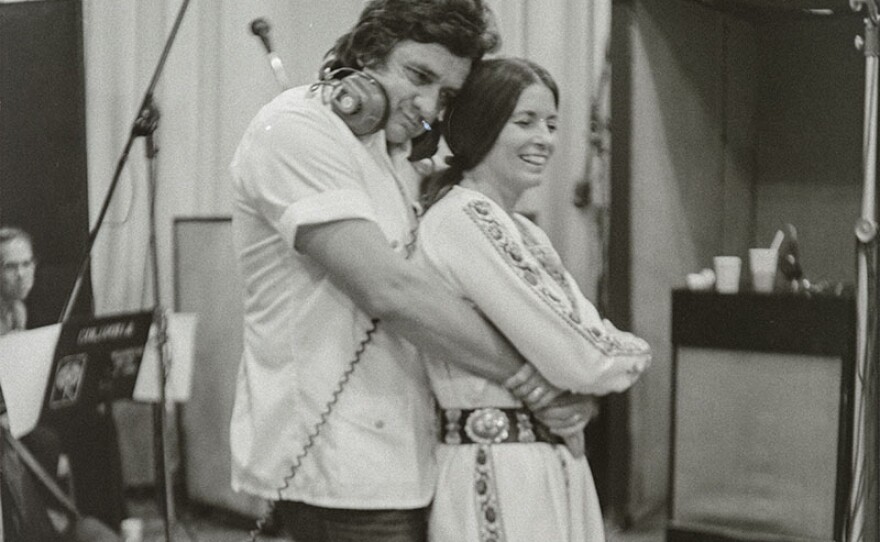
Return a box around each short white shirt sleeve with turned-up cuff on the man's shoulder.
[232,96,375,251]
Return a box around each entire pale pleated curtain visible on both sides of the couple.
[82,0,611,492]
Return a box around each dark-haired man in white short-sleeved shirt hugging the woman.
[231,0,583,542]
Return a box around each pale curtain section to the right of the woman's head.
[491,0,611,301]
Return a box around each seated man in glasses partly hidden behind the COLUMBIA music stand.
[0,227,124,542]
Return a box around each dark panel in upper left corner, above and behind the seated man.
[0,0,91,327]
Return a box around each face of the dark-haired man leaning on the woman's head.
[364,40,471,145]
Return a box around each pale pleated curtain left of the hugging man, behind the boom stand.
[82,0,362,486]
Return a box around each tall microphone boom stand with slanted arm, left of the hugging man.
[60,0,190,542]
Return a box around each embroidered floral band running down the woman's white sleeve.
[463,198,645,355]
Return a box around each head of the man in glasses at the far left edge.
[0,227,35,335]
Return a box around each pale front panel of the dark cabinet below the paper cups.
[672,347,842,540]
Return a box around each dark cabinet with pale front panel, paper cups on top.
[667,290,856,542]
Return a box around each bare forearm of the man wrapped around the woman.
[295,220,525,383]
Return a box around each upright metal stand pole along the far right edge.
[844,0,880,541]
